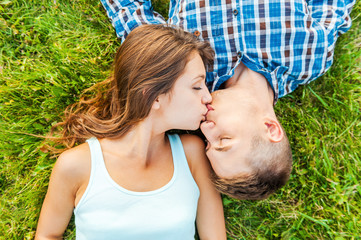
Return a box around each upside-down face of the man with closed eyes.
[201,88,259,178]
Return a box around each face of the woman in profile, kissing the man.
[160,52,212,130]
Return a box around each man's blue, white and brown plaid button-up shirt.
[101,0,355,102]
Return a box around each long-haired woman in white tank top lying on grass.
[36,25,226,240]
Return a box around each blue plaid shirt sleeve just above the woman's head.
[101,0,166,42]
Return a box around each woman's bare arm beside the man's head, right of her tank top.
[181,135,227,240]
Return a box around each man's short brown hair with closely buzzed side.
[212,132,292,200]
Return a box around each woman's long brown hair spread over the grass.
[53,25,214,148]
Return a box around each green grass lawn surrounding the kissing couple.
[0,0,361,239]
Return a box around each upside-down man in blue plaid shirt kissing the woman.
[101,0,355,199]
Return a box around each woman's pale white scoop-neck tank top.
[74,135,199,240]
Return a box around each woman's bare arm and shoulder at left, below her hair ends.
[35,144,90,240]
